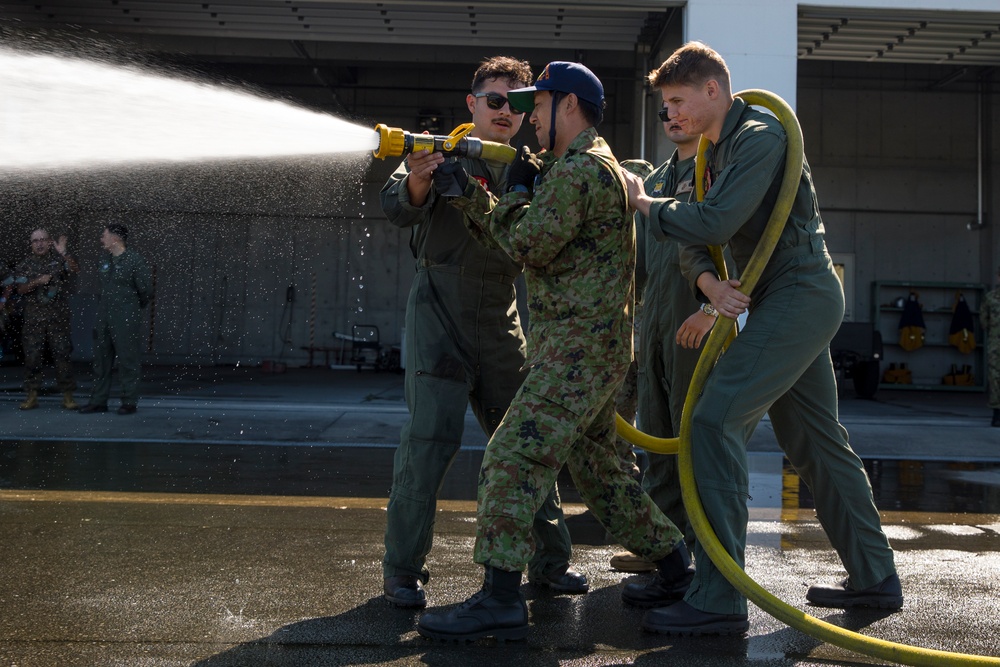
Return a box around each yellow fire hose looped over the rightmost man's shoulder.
[617,90,1000,667]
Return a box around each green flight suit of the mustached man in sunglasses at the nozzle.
[380,153,572,583]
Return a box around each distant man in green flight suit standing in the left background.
[80,223,153,415]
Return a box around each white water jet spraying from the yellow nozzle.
[0,49,378,173]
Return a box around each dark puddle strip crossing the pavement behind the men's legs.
[0,440,1000,514]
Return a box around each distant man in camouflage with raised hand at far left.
[14,228,80,410]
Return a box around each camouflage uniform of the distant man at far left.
[14,249,76,393]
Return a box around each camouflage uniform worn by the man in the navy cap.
[455,128,682,572]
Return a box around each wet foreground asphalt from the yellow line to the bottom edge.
[0,464,1000,667]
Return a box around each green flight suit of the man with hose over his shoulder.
[649,99,896,614]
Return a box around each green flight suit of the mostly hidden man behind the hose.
[636,152,701,547]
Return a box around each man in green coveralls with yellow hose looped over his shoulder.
[625,42,903,635]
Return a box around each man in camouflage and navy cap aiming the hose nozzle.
[417,62,691,640]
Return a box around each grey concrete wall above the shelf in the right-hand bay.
[798,66,988,298]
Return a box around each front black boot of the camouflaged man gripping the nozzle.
[417,565,528,642]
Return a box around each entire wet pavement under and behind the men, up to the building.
[0,367,1000,667]
